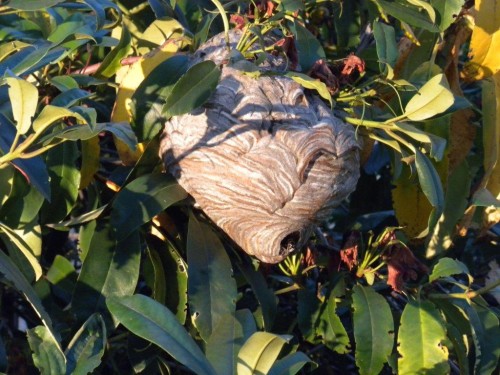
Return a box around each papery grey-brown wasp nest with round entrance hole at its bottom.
[160,31,359,263]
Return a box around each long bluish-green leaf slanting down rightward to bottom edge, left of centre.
[106,294,216,375]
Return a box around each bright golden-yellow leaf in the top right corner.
[463,0,500,81]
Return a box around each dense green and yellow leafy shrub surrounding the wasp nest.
[0,0,500,374]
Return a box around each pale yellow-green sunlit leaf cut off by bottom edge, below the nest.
[236,332,292,375]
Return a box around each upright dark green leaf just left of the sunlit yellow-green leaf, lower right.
[352,285,394,374]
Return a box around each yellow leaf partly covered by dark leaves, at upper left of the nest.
[111,40,184,165]
